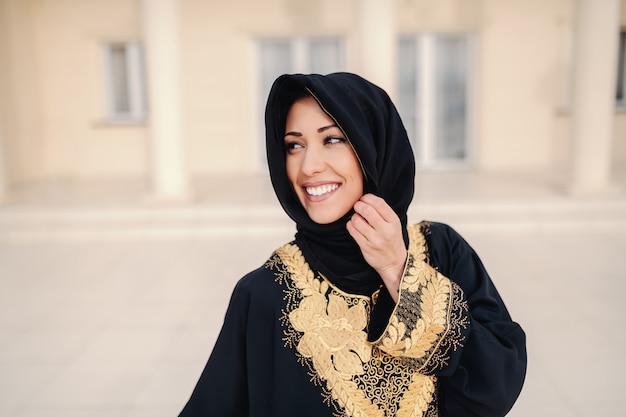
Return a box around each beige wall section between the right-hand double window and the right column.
[478,0,571,170]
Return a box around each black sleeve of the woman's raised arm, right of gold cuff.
[424,223,526,417]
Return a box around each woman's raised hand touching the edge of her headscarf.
[347,194,407,302]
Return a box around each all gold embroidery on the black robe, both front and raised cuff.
[266,223,462,417]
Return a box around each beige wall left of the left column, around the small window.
[0,0,147,183]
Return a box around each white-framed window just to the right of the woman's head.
[398,34,472,167]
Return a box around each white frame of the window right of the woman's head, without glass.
[399,33,476,170]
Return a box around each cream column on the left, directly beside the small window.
[141,0,188,200]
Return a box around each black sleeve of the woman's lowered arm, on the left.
[180,274,250,417]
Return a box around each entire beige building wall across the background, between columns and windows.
[0,0,626,183]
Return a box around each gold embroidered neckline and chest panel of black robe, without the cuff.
[268,225,444,417]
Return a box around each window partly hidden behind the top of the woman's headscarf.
[257,37,345,166]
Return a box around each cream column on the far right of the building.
[572,0,619,194]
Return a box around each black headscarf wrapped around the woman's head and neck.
[265,72,415,295]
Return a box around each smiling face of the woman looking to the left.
[285,97,363,224]
